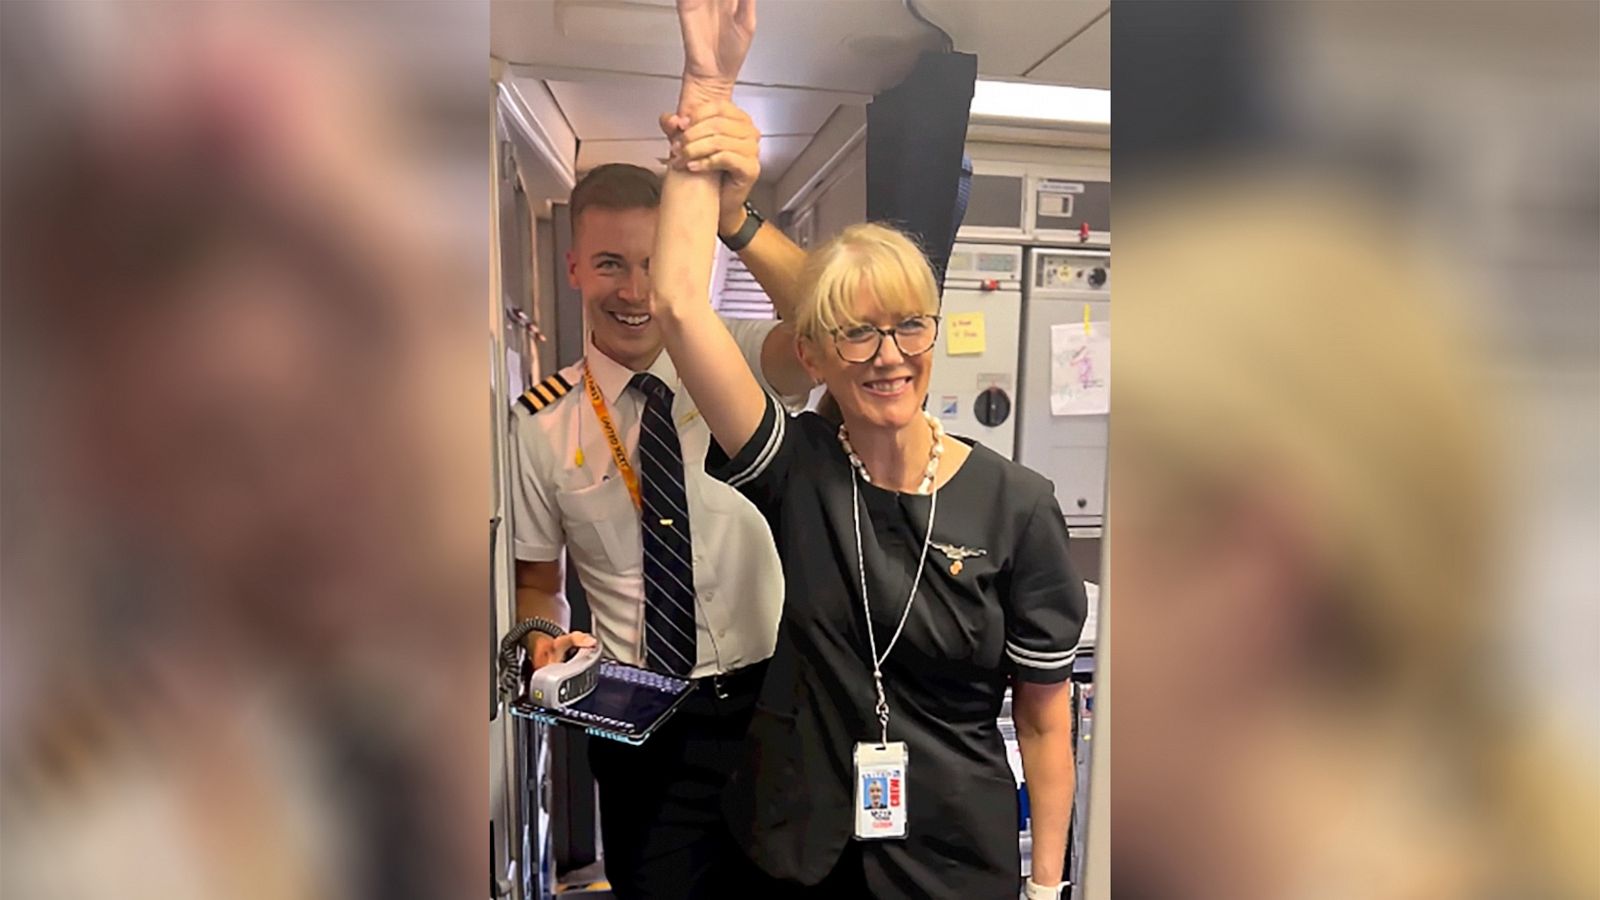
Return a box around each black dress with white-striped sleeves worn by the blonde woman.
[707,400,1085,900]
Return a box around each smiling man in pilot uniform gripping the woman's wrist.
[512,119,811,898]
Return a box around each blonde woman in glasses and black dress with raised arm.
[651,0,1085,898]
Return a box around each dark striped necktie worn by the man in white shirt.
[629,372,696,676]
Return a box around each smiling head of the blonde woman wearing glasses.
[798,224,939,431]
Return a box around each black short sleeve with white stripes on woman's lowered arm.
[1002,490,1088,684]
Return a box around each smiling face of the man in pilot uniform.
[566,207,661,370]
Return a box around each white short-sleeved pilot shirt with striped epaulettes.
[512,319,796,677]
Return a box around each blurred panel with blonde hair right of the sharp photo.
[1101,3,1600,900]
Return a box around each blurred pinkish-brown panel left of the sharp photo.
[0,2,490,898]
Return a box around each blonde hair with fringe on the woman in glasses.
[795,223,939,341]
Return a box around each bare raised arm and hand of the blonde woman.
[651,0,766,456]
